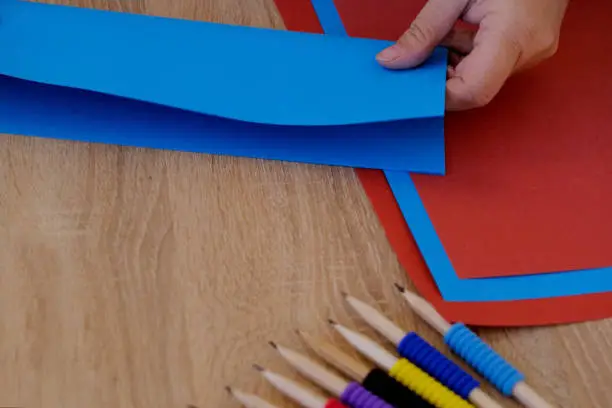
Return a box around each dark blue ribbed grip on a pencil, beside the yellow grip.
[397,332,480,399]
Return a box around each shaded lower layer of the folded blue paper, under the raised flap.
[0,76,439,168]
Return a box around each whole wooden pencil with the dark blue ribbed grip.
[342,293,501,408]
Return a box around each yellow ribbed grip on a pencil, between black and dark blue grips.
[389,358,474,408]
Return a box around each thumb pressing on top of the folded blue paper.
[376,0,468,69]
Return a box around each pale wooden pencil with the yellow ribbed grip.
[329,320,474,408]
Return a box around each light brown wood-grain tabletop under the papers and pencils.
[0,0,612,408]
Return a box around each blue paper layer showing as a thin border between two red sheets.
[311,0,612,302]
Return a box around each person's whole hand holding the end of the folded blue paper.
[376,0,569,110]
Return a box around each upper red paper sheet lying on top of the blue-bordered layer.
[335,0,612,279]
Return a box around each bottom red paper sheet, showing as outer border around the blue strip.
[275,0,612,326]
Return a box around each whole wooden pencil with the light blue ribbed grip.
[395,284,553,408]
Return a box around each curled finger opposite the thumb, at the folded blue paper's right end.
[446,26,521,110]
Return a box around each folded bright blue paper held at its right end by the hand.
[0,0,446,174]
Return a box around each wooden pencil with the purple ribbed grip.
[270,342,393,408]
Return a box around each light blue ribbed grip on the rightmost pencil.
[444,323,525,396]
